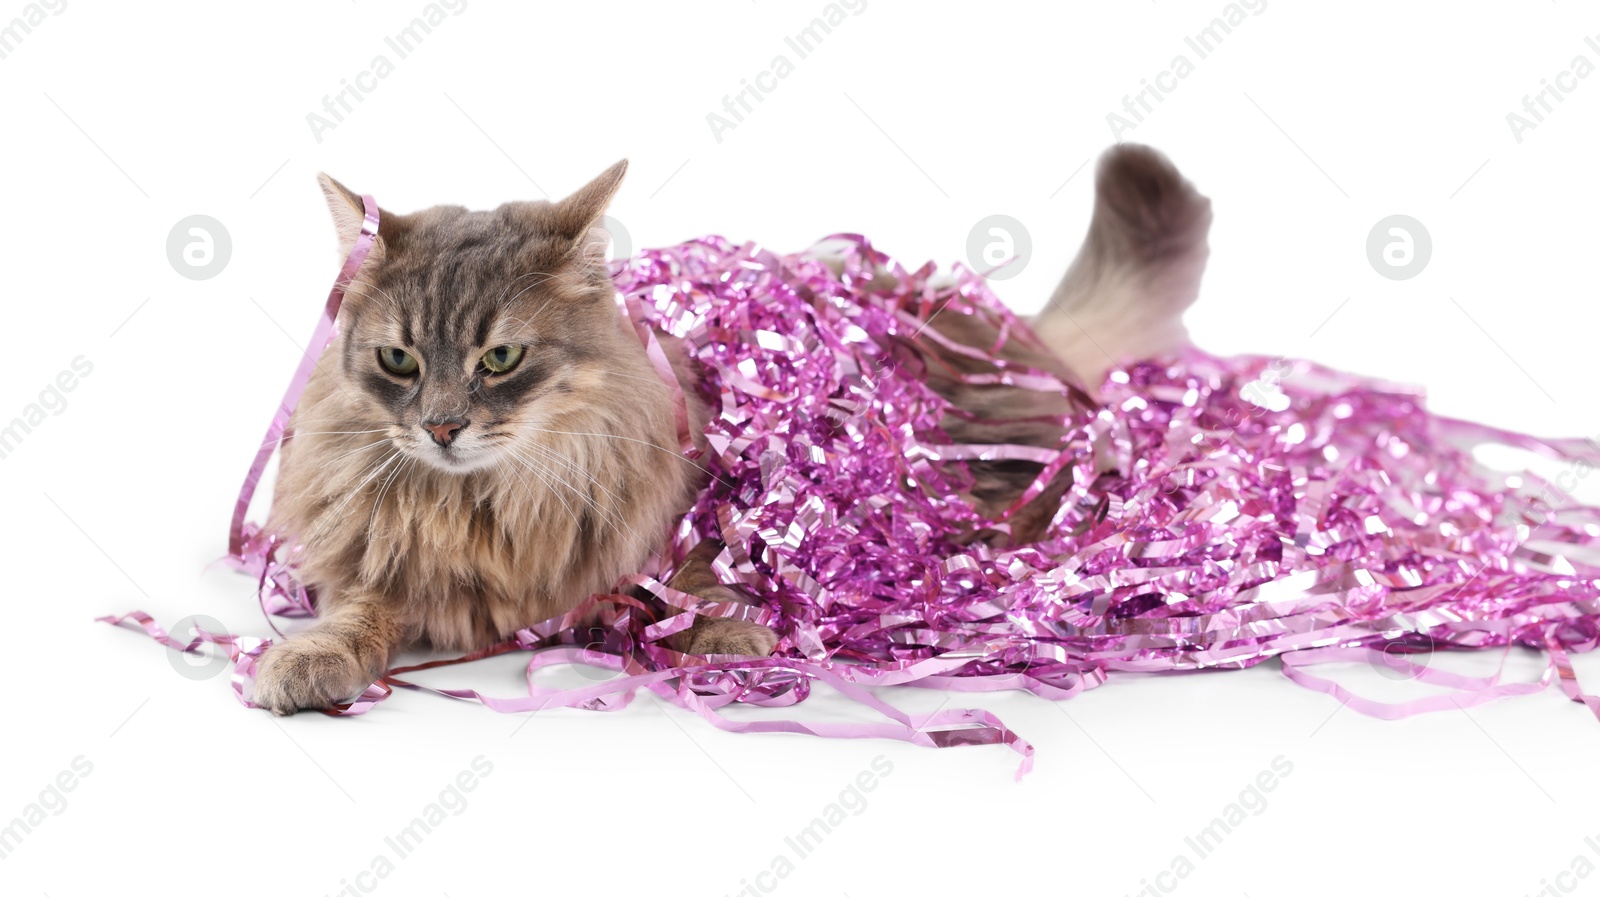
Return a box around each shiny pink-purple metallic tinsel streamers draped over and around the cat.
[96,219,1600,775]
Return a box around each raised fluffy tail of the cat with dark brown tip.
[1034,144,1211,389]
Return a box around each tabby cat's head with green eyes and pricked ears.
[320,160,642,473]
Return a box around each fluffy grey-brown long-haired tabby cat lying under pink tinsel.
[253,144,1210,715]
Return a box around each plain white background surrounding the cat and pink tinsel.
[0,0,1600,897]
